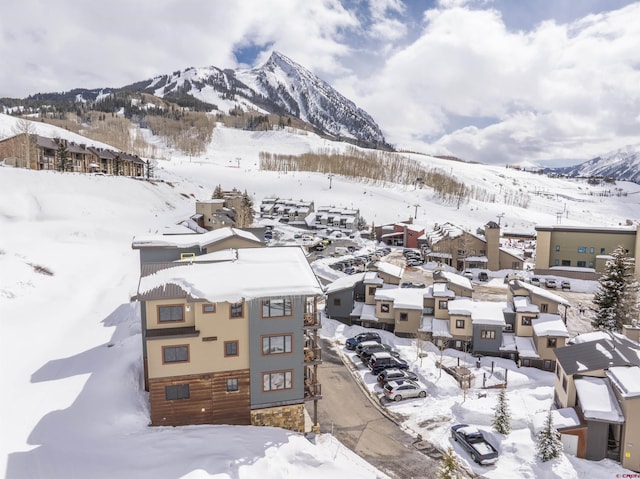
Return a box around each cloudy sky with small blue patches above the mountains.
[0,0,640,163]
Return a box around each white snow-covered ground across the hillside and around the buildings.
[0,115,640,479]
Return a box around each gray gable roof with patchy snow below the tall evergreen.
[553,335,640,376]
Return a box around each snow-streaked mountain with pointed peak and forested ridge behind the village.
[0,52,390,148]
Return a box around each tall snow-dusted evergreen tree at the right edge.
[592,246,638,332]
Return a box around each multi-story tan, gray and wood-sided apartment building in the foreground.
[135,247,323,431]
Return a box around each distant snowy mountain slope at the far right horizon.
[545,145,640,184]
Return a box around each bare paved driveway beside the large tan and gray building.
[318,340,462,479]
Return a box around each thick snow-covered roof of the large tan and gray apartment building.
[138,247,322,302]
